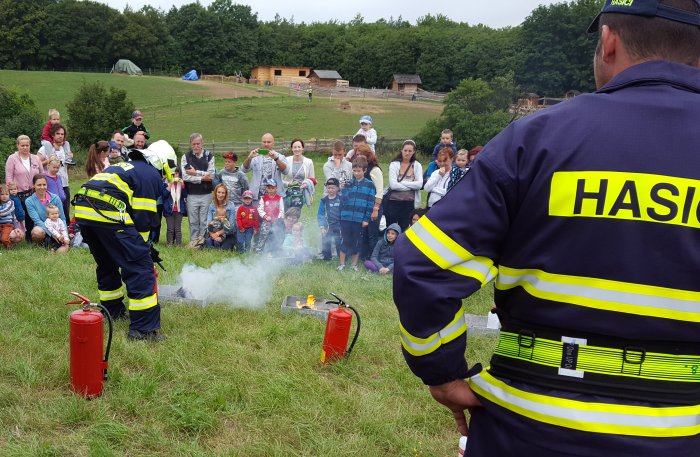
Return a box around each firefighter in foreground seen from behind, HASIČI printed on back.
[394,0,700,457]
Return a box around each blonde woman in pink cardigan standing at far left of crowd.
[5,135,44,239]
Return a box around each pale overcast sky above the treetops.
[97,0,564,28]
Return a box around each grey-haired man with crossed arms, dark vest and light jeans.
[180,133,216,247]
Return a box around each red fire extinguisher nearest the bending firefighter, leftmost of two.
[68,292,112,398]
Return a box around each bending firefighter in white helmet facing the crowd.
[73,140,177,341]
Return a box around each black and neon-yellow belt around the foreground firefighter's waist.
[489,325,700,405]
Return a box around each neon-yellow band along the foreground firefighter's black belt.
[495,331,700,382]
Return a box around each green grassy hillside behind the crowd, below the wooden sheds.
[0,70,442,147]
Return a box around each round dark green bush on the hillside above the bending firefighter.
[67,83,134,149]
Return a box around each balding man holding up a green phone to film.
[241,133,289,207]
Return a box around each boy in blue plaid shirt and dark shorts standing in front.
[338,156,376,271]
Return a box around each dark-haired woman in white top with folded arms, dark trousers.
[382,140,423,232]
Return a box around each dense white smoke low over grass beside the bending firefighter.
[179,257,282,308]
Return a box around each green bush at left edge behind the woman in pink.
[0,86,43,180]
